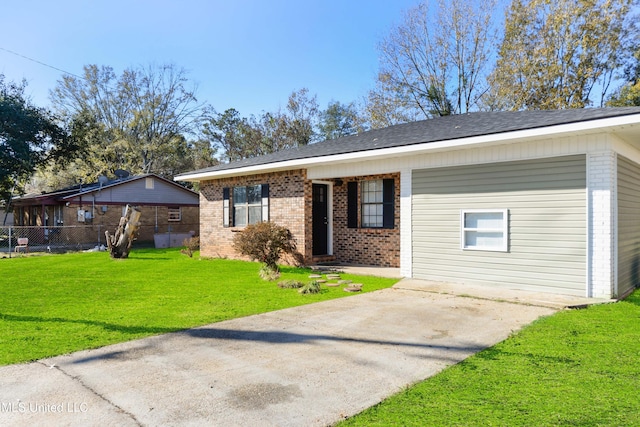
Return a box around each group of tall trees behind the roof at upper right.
[365,0,640,127]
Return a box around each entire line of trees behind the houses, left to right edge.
[0,0,640,199]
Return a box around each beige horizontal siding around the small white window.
[412,155,587,295]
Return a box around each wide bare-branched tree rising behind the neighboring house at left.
[51,65,202,178]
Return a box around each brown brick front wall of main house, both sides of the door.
[200,170,400,267]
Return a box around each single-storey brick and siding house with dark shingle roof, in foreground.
[176,108,640,298]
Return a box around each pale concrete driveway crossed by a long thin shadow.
[0,282,555,426]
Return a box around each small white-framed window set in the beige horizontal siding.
[460,209,509,252]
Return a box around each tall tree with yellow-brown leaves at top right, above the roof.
[487,0,634,110]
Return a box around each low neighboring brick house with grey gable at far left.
[12,174,199,247]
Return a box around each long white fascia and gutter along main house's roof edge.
[174,114,640,182]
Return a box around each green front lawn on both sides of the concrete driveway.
[6,249,640,426]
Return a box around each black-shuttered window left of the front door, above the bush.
[223,184,269,227]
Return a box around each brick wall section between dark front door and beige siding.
[333,174,400,268]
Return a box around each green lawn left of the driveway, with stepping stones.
[0,249,397,365]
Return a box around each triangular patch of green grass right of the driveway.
[340,291,640,427]
